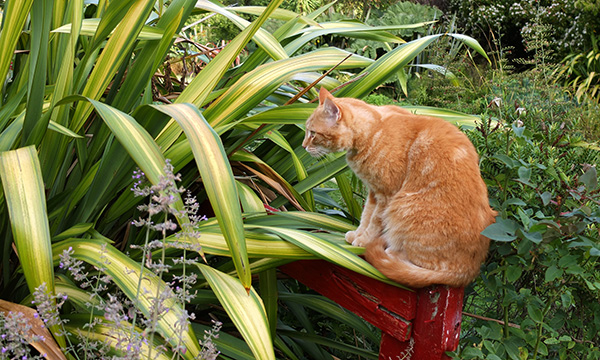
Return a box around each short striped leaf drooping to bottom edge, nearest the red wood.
[197,264,275,360]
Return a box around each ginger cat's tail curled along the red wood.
[365,238,479,288]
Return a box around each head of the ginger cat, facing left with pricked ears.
[302,88,351,157]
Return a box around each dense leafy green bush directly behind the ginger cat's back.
[457,109,600,359]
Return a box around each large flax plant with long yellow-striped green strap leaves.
[0,0,485,359]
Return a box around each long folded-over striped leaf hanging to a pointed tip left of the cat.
[153,104,252,289]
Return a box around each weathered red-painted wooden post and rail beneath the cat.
[280,260,464,360]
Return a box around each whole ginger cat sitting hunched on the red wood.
[302,88,496,288]
